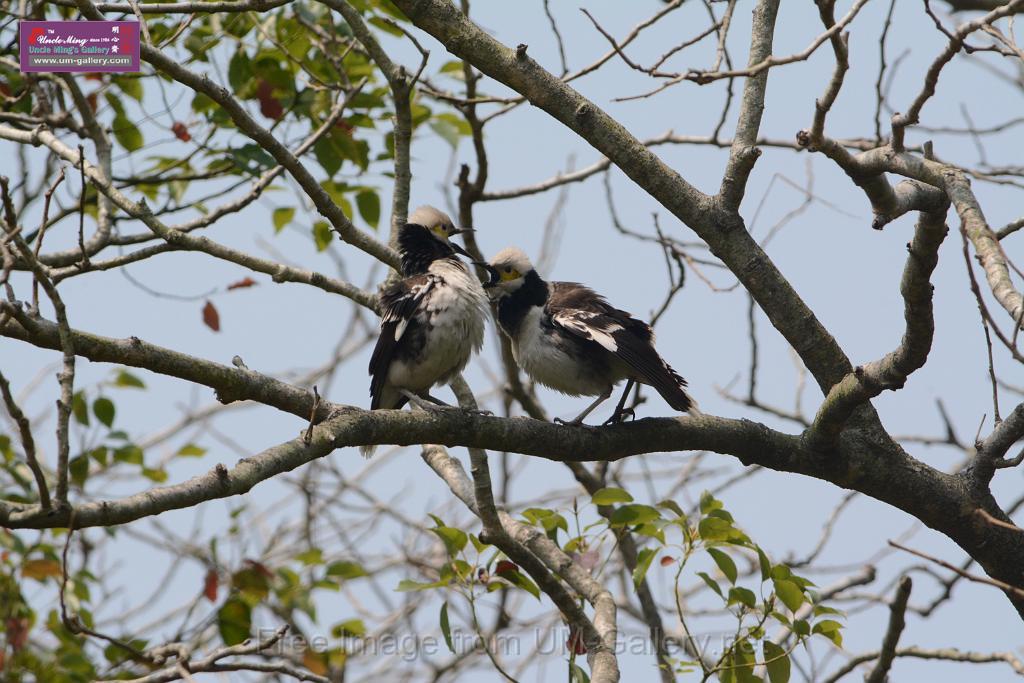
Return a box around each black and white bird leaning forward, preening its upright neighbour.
[484,247,699,424]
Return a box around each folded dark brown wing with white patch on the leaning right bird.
[547,283,693,411]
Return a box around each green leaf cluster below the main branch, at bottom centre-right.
[397,488,843,683]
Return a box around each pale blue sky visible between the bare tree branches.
[0,0,1022,682]
